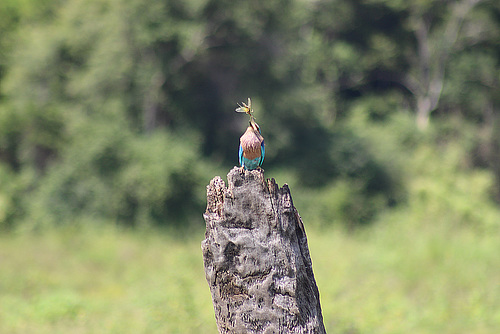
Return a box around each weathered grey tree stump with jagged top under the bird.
[202,167,326,334]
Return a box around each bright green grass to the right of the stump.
[310,222,500,334]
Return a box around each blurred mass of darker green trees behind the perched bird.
[0,0,500,224]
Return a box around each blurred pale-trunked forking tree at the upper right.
[398,0,482,129]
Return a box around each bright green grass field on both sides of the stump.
[0,214,500,334]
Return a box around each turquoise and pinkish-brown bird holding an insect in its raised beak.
[235,98,266,170]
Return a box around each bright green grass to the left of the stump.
[0,227,217,333]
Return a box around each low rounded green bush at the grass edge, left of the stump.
[24,122,207,226]
